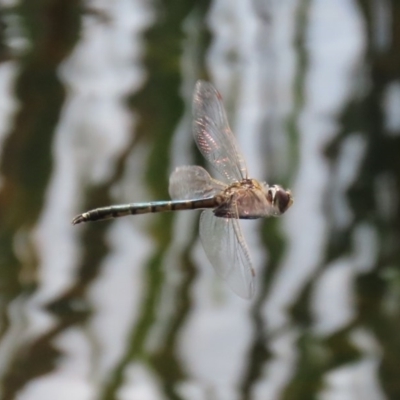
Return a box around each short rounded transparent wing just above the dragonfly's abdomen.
[169,165,226,200]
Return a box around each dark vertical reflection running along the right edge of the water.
[352,0,400,399]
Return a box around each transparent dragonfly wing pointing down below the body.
[200,210,255,299]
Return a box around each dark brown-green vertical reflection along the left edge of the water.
[0,0,80,399]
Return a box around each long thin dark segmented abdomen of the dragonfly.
[72,197,219,225]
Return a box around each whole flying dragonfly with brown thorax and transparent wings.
[72,80,293,299]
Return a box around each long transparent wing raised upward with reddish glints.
[193,81,247,183]
